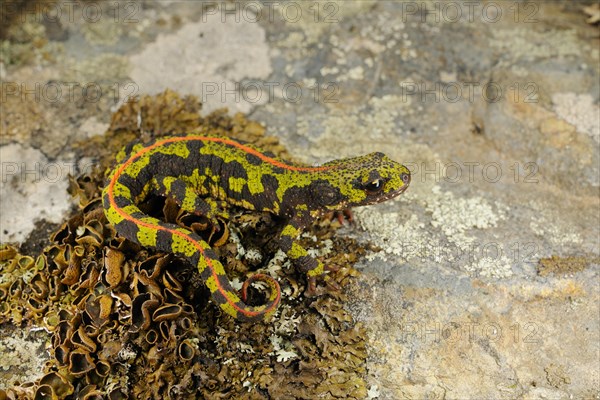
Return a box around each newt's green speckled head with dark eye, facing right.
[311,153,410,211]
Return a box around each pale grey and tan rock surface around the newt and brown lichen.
[0,1,600,399]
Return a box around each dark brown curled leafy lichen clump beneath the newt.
[0,91,367,399]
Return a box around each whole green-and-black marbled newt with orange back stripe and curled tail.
[102,135,410,321]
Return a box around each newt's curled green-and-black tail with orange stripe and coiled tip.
[102,165,281,321]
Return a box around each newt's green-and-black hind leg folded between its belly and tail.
[153,176,229,232]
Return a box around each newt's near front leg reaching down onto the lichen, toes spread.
[279,213,340,294]
